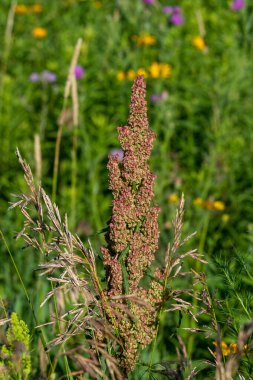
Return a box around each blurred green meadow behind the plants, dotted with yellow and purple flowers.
[0,0,253,378]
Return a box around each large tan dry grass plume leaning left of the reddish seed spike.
[11,150,123,379]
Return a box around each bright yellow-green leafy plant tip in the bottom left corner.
[0,313,31,380]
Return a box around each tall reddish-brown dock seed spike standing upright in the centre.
[102,76,162,371]
